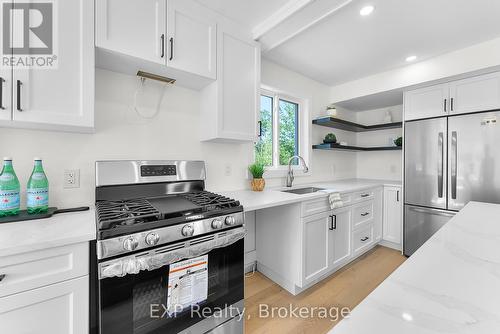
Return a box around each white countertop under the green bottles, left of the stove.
[0,209,96,257]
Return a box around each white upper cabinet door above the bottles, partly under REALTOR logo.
[13,0,94,128]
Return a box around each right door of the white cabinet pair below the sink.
[329,208,352,269]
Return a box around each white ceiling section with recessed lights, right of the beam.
[264,0,500,85]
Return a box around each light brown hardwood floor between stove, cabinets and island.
[245,246,406,334]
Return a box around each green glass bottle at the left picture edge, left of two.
[0,158,21,217]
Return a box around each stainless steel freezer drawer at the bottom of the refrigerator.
[403,205,455,256]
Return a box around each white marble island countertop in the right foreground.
[330,202,500,334]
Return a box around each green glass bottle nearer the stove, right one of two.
[26,158,49,214]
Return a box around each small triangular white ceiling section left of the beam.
[196,0,289,28]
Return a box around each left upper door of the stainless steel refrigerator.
[405,118,447,209]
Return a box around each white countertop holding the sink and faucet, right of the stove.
[221,179,401,211]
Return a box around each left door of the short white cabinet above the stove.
[94,0,167,64]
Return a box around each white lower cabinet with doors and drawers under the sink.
[255,187,383,295]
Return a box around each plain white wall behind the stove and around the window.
[0,61,356,207]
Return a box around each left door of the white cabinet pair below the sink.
[302,212,331,285]
